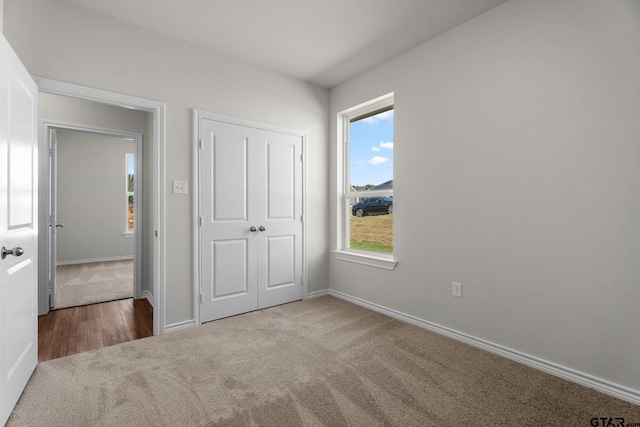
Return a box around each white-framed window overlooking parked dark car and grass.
[335,94,395,269]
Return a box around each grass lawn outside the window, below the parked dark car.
[349,214,393,253]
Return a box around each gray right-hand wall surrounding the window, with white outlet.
[330,0,640,393]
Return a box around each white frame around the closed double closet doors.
[191,109,308,326]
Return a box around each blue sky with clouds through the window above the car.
[349,110,393,186]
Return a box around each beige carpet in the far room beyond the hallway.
[54,260,133,309]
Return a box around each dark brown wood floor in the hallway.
[38,298,153,362]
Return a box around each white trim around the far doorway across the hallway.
[38,120,144,308]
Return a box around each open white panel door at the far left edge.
[0,35,38,424]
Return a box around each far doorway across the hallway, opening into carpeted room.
[43,122,143,309]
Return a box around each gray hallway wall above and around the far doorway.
[38,93,153,314]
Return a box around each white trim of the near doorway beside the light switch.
[33,77,166,335]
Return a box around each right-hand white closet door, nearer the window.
[258,131,302,308]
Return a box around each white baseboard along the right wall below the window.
[330,290,640,405]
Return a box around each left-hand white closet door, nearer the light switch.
[200,120,264,322]
